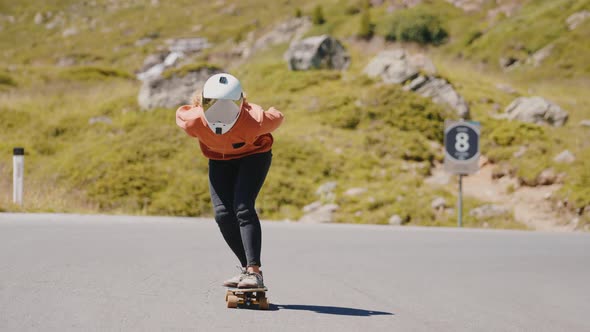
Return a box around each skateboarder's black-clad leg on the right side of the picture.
[234,151,272,273]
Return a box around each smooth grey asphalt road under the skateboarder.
[0,214,590,332]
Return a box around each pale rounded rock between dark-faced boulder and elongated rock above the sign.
[364,49,418,84]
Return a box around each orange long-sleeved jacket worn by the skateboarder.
[176,101,283,160]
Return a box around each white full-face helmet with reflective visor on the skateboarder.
[202,73,243,135]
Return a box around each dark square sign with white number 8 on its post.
[445,120,481,227]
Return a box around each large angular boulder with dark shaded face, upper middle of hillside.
[285,35,350,70]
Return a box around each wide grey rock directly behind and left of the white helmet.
[137,67,222,110]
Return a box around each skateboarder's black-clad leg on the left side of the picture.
[209,160,248,268]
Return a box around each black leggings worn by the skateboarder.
[209,151,272,267]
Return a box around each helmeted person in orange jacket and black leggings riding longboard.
[176,73,284,288]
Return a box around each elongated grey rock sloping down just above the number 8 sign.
[404,76,469,119]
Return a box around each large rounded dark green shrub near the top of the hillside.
[386,10,448,45]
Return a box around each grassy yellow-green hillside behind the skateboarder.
[0,0,590,228]
